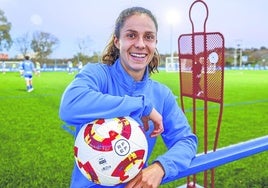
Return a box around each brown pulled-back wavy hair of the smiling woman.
[102,7,160,73]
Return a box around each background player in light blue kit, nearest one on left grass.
[20,56,35,92]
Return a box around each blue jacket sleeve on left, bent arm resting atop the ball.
[59,65,152,125]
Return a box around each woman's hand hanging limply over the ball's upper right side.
[141,108,164,137]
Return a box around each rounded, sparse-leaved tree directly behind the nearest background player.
[31,31,59,61]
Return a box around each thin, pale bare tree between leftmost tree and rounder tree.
[14,33,31,56]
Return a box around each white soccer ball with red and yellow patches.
[74,117,148,186]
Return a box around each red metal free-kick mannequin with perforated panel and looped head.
[178,0,224,188]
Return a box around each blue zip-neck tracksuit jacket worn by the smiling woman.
[59,59,197,188]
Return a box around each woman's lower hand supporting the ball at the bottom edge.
[126,162,165,188]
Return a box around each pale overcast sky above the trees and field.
[0,0,268,58]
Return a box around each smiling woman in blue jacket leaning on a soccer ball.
[59,7,197,188]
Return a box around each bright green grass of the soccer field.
[0,71,268,188]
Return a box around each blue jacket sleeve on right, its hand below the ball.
[153,92,197,182]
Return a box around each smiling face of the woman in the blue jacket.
[114,14,157,80]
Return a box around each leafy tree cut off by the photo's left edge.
[0,10,12,51]
